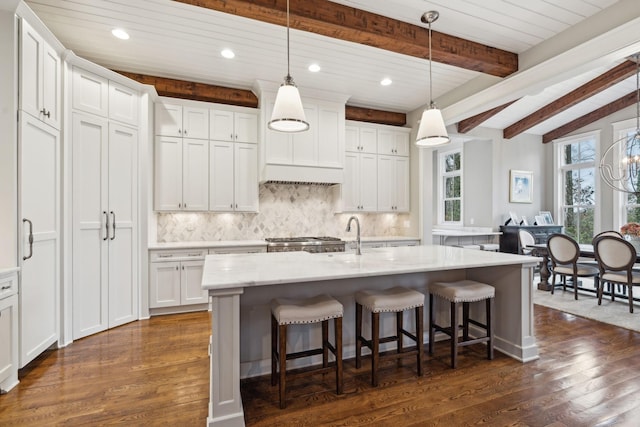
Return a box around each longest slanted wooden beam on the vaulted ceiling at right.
[503,61,637,139]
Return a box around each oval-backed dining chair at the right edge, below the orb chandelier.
[593,236,640,313]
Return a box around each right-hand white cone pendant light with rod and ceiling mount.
[416,10,450,147]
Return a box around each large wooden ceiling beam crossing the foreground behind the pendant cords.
[174,0,518,77]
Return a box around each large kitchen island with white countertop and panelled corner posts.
[202,245,540,426]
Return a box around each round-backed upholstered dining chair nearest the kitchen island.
[547,233,600,299]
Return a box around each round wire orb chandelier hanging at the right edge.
[600,54,640,195]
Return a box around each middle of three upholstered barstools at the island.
[355,287,424,387]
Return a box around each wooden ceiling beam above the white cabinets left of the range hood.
[113,70,258,108]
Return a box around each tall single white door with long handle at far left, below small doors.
[18,114,60,368]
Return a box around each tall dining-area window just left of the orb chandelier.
[556,134,598,243]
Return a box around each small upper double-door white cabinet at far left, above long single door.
[19,19,62,129]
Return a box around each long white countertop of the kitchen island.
[202,245,541,290]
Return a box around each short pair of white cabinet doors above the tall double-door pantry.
[71,66,140,127]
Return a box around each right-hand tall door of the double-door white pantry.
[103,123,139,328]
